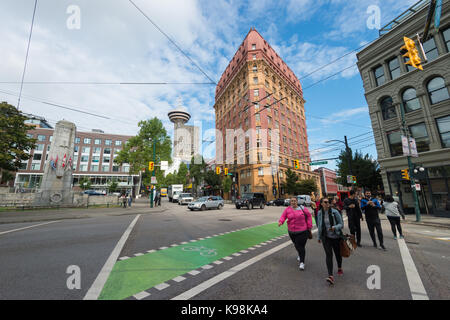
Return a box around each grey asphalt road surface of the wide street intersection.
[0,203,450,300]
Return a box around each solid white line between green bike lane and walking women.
[171,229,317,300]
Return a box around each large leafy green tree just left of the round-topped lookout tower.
[114,118,172,174]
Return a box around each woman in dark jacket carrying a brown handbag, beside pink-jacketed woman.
[317,198,344,285]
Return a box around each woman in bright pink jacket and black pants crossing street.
[278,197,312,270]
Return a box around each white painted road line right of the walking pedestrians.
[397,239,429,300]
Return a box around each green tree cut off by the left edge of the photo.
[0,102,36,179]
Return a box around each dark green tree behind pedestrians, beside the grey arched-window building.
[336,151,383,190]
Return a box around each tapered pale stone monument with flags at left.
[34,120,76,206]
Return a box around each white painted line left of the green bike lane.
[83,214,141,300]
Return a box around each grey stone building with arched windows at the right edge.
[357,0,450,215]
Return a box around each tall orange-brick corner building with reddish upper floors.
[214,29,320,199]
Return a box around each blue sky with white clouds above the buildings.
[0,0,417,169]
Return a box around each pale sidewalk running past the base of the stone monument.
[0,199,167,224]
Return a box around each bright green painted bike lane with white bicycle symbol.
[99,223,296,300]
